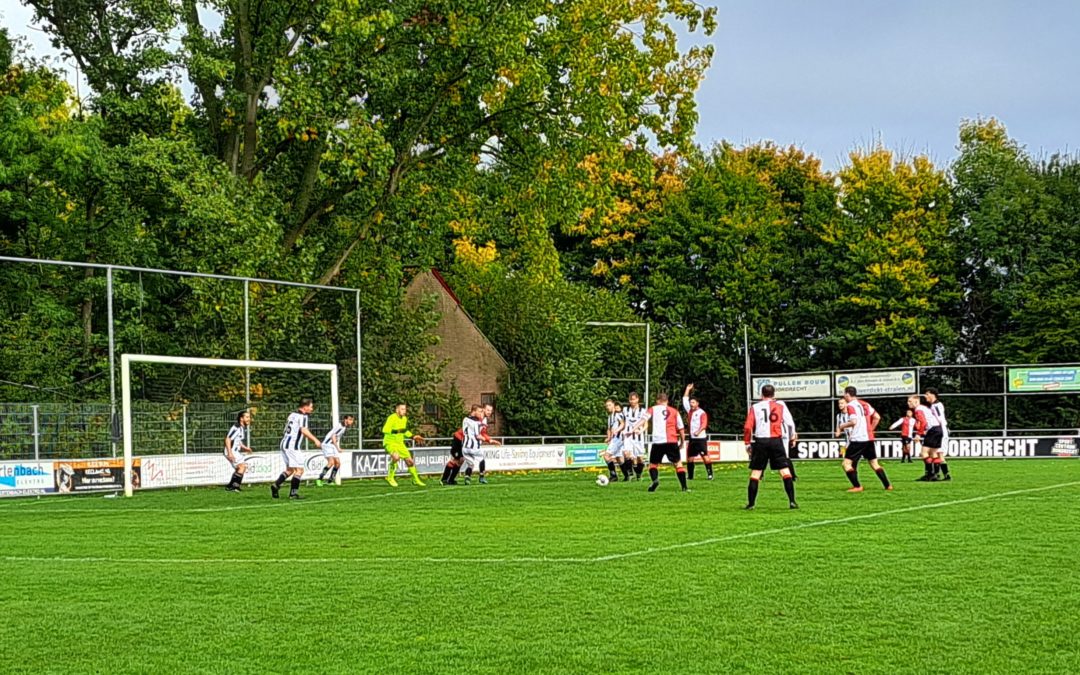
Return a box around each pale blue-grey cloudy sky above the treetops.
[0,0,1080,168]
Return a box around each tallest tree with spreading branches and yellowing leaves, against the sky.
[27,0,714,283]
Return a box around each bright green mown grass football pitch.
[0,460,1080,673]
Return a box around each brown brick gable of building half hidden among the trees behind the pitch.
[405,270,509,435]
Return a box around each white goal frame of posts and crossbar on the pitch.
[120,354,340,497]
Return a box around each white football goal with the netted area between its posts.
[120,354,340,497]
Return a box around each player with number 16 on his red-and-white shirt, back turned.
[743,384,799,511]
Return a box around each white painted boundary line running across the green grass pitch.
[0,481,1080,565]
